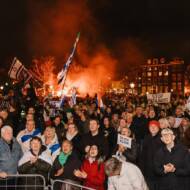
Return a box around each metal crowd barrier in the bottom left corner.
[0,174,47,190]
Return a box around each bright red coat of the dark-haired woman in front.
[81,159,105,190]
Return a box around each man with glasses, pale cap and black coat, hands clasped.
[154,128,190,190]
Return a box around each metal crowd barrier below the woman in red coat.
[52,180,96,190]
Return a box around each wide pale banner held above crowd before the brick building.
[147,93,171,104]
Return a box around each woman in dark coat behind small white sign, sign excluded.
[114,127,137,163]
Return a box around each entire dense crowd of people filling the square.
[0,83,190,190]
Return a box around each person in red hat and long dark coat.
[140,120,163,190]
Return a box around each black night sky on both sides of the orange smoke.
[0,0,190,71]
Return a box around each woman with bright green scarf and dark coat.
[50,140,81,190]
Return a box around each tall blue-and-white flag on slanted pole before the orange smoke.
[57,32,80,84]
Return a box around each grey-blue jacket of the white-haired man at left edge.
[0,138,22,174]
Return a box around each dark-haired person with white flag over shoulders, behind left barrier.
[18,137,52,190]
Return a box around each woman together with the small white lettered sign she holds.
[114,127,137,163]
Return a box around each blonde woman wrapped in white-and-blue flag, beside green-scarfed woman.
[42,126,60,161]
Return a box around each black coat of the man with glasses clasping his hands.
[154,144,190,190]
